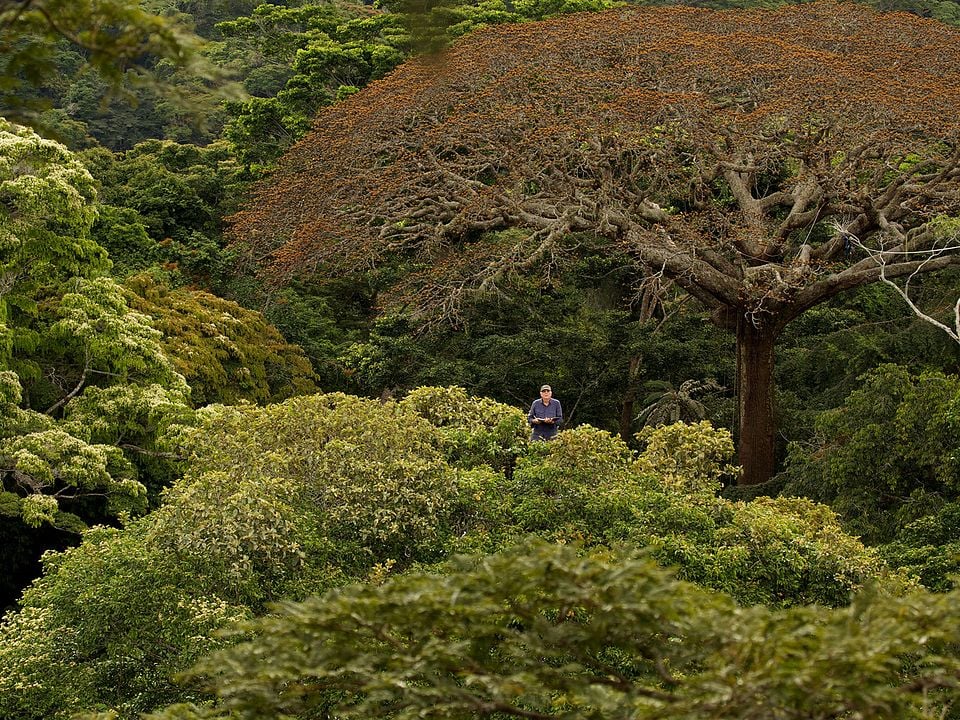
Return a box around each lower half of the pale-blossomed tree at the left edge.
[0,278,189,526]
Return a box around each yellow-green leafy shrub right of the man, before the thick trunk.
[488,423,910,606]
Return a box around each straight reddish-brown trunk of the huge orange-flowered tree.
[737,318,777,485]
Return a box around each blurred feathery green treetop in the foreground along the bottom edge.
[159,543,960,720]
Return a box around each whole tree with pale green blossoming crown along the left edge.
[0,122,189,529]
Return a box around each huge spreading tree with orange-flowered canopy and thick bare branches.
[234,2,960,484]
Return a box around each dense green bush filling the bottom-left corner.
[0,521,249,720]
